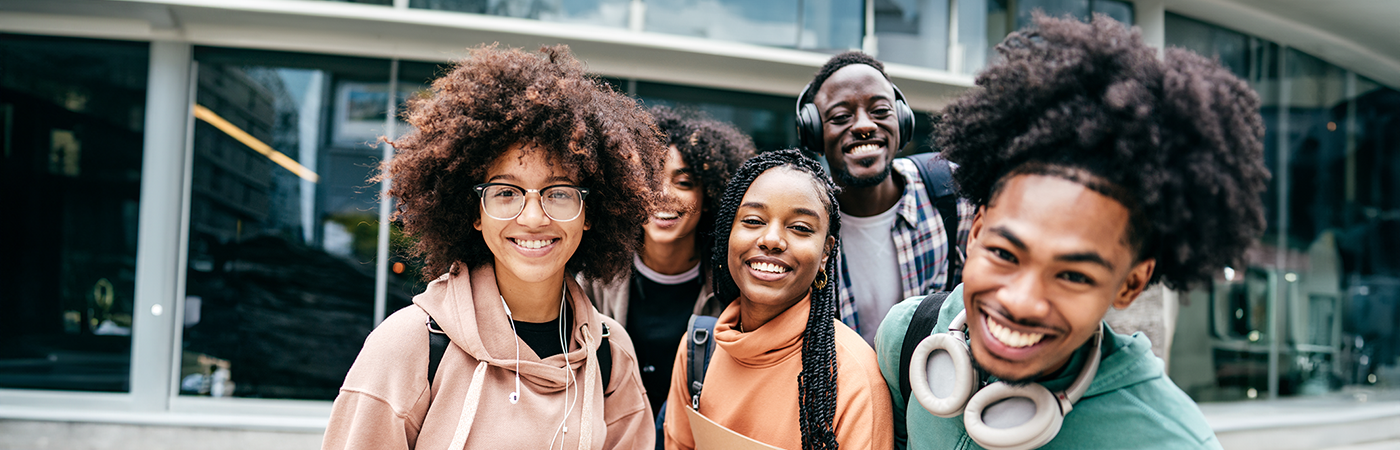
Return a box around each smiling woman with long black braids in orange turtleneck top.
[665,150,893,450]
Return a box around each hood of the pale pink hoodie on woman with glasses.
[413,264,602,391]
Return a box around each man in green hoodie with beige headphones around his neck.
[876,14,1268,449]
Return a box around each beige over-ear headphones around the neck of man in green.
[909,311,1103,450]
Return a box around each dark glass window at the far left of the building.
[0,34,150,393]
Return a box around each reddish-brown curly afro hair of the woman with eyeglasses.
[378,45,665,280]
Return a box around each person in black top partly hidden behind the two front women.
[578,107,755,417]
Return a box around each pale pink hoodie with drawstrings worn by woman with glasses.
[321,265,655,450]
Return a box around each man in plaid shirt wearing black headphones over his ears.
[798,52,974,342]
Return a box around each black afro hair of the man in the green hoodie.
[934,14,1270,289]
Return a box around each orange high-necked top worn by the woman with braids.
[665,294,895,450]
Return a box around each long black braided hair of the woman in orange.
[710,149,841,450]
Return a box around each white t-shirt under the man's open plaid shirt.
[841,202,904,345]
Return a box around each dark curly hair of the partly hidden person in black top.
[647,107,756,261]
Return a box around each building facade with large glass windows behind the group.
[0,0,1400,447]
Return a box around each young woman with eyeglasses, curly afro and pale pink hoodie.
[322,46,665,449]
